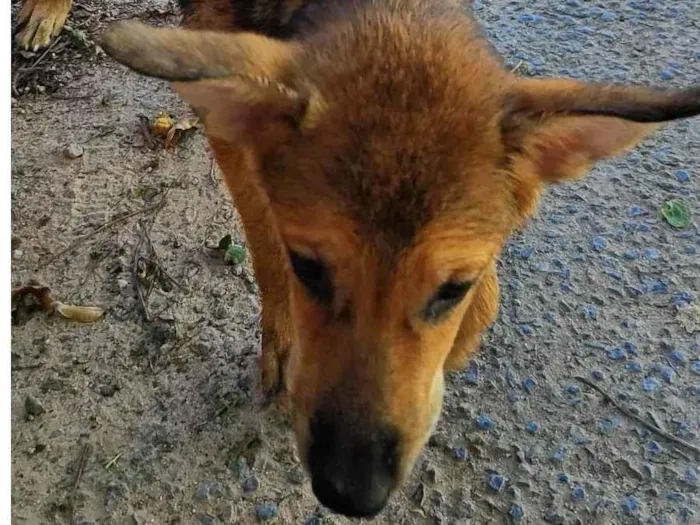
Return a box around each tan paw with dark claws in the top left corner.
[17,0,72,51]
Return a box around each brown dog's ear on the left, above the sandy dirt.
[102,22,318,149]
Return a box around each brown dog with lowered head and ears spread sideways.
[103,0,700,516]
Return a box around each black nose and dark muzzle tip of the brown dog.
[308,414,398,518]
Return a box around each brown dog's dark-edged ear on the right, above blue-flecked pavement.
[502,79,700,182]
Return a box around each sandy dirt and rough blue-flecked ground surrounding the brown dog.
[12,0,700,525]
